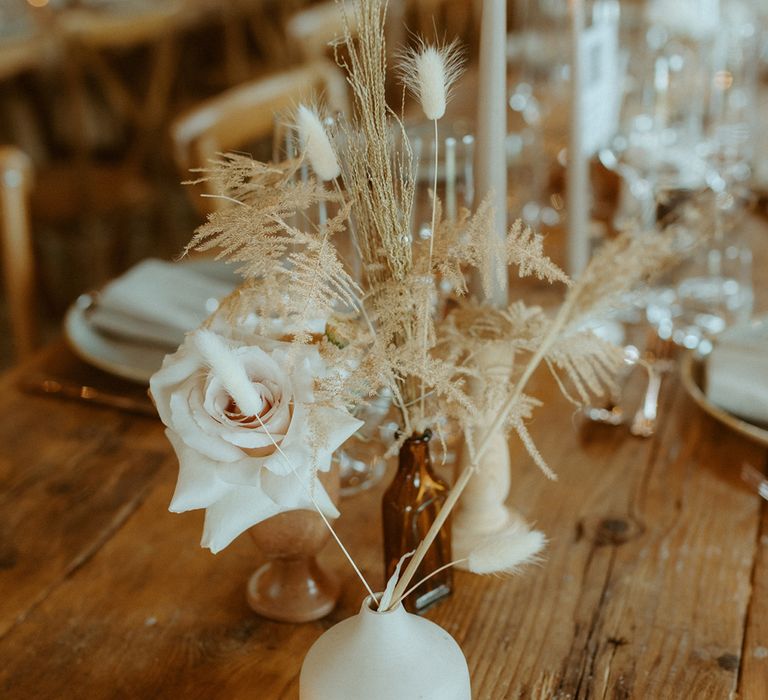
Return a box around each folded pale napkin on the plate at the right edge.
[706,316,768,423]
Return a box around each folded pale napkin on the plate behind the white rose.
[88,259,236,349]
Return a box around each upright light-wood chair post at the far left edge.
[0,146,37,359]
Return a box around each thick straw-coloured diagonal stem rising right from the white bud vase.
[387,288,584,610]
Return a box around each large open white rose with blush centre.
[150,331,362,553]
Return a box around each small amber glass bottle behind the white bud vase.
[382,430,453,612]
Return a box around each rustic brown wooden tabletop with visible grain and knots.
[0,225,768,700]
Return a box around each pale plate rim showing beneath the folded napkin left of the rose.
[64,294,172,384]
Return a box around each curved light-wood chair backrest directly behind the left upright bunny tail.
[171,60,349,214]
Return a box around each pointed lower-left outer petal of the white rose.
[165,429,233,513]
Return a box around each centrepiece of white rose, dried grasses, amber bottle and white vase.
[151,0,674,699]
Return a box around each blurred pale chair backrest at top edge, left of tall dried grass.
[285,0,357,60]
